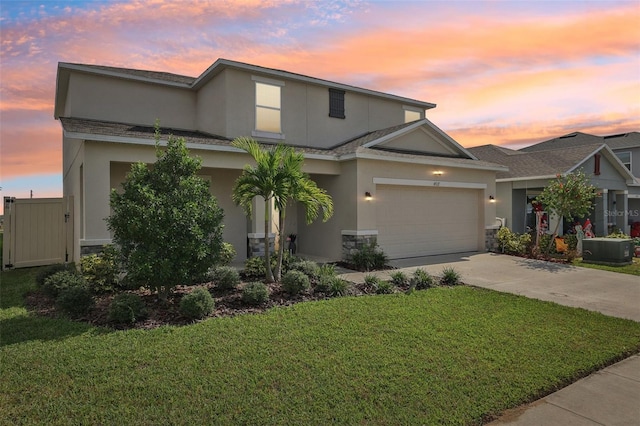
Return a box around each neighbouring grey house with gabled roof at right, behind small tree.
[469,132,640,236]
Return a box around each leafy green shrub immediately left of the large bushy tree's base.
[80,245,120,293]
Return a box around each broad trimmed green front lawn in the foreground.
[0,270,640,425]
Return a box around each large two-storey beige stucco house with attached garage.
[55,59,506,260]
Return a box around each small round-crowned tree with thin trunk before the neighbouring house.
[536,170,597,252]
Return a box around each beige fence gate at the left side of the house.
[2,197,73,269]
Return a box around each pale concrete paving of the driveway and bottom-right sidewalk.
[342,253,640,426]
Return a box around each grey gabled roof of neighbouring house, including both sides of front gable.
[469,143,634,183]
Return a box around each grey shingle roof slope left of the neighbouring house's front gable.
[468,143,604,179]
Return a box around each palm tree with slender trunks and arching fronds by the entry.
[232,137,333,282]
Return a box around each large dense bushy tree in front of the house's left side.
[107,123,223,300]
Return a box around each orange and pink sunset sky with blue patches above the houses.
[0,0,640,213]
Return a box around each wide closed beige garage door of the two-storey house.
[375,185,480,259]
